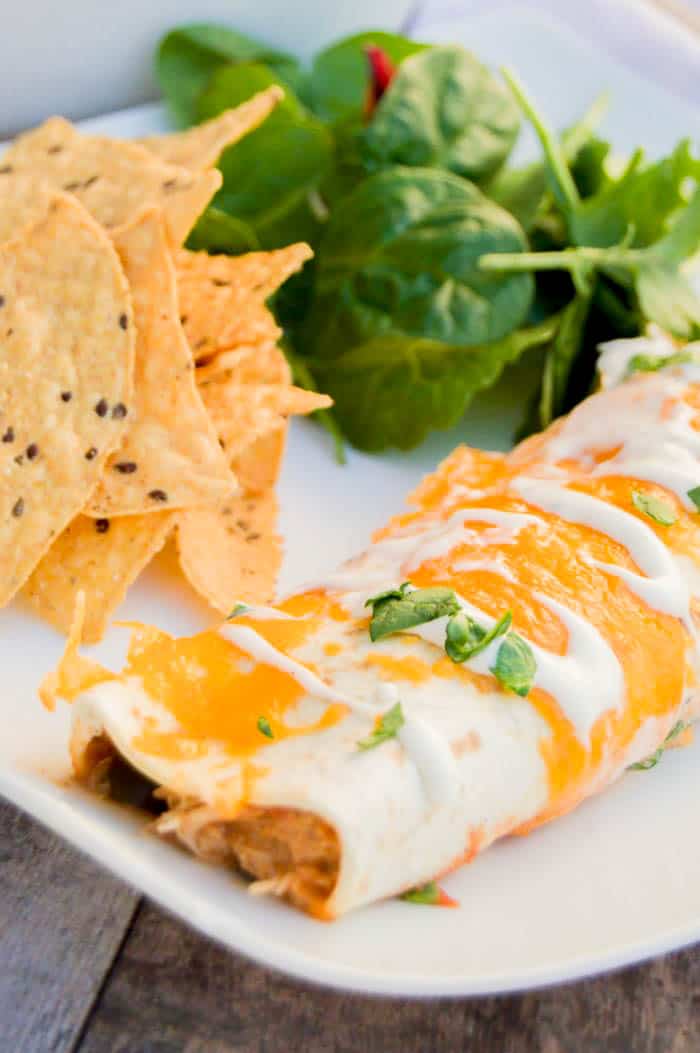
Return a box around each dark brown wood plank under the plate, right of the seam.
[77,905,700,1053]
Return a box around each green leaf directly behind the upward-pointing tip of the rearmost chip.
[197,63,332,249]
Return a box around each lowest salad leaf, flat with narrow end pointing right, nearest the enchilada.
[314,311,557,451]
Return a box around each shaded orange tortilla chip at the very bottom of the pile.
[23,512,176,643]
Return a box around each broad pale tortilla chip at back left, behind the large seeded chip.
[0,117,221,245]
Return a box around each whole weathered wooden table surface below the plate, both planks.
[0,803,700,1053]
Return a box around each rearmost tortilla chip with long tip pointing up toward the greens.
[138,84,284,172]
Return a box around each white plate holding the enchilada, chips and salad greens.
[0,8,700,995]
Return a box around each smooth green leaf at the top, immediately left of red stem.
[308,29,427,122]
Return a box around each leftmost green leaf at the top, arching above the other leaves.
[156,23,301,127]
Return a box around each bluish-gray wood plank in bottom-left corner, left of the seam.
[0,800,139,1053]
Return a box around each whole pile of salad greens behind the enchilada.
[156,24,700,451]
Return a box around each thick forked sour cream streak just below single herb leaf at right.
[513,476,695,635]
